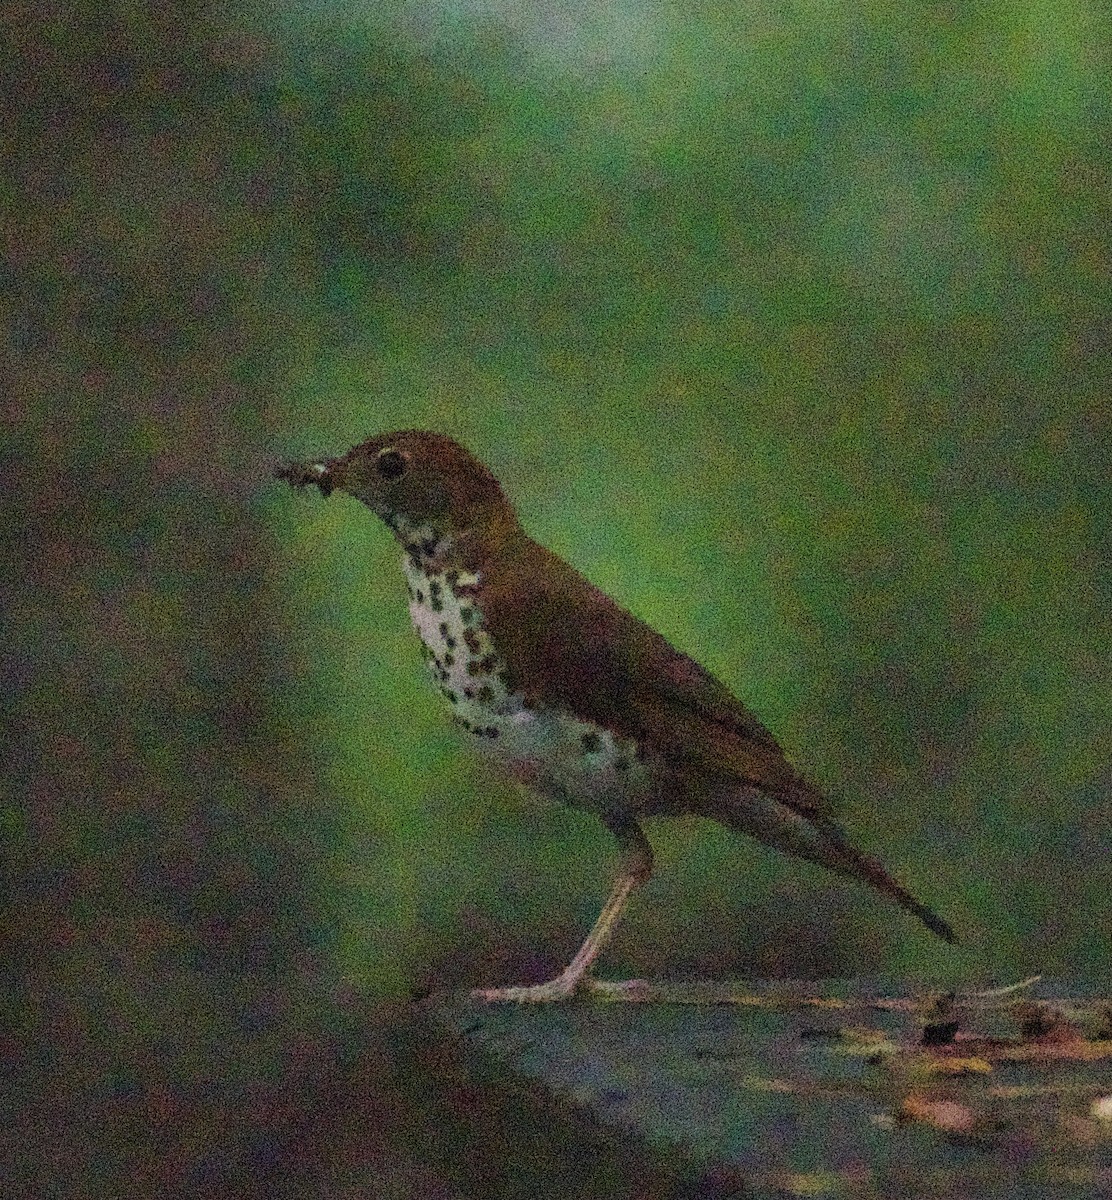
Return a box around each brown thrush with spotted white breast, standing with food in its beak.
[275,430,956,1003]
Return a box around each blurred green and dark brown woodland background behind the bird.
[0,0,1112,1195]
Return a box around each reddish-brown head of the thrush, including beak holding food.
[277,430,517,541]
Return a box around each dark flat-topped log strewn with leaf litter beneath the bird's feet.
[415,982,1112,1200]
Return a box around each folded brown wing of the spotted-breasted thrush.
[480,538,827,816]
